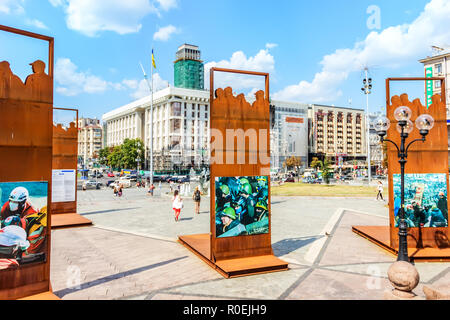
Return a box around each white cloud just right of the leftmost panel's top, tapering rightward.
[55,58,124,96]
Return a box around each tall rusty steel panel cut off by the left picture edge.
[0,25,54,299]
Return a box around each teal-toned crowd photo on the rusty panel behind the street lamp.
[393,173,448,228]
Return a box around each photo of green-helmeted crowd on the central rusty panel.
[215,176,269,238]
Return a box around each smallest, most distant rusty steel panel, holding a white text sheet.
[52,108,78,214]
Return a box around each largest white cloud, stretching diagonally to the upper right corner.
[273,0,450,102]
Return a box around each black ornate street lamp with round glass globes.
[374,106,434,262]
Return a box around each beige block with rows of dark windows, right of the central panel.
[308,104,367,165]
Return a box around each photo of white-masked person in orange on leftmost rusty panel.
[0,181,48,270]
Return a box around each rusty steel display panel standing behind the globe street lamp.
[386,77,449,248]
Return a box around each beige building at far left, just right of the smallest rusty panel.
[78,118,102,164]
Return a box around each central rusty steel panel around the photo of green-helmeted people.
[210,68,273,262]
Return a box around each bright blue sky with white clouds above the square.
[0,0,450,118]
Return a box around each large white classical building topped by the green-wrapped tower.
[102,87,209,170]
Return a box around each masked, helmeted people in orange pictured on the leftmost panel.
[0,187,47,269]
